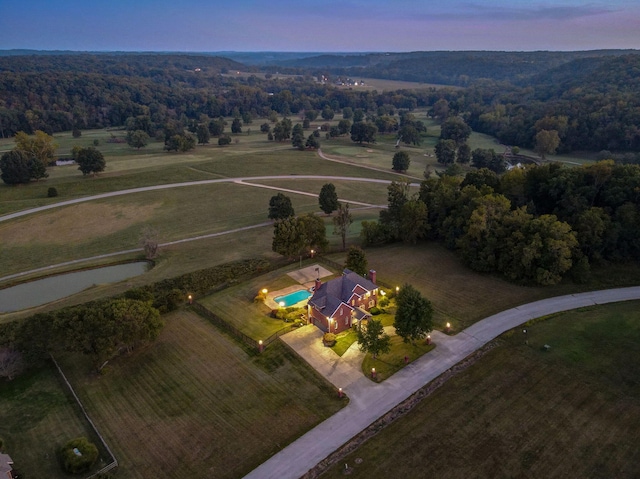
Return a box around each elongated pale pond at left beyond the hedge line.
[0,261,148,313]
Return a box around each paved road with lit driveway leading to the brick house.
[245,287,640,479]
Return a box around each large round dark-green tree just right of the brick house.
[393,284,433,342]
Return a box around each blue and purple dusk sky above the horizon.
[0,0,640,52]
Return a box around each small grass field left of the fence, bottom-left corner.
[0,365,110,479]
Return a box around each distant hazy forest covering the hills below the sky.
[0,50,640,161]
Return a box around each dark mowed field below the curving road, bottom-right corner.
[322,301,640,479]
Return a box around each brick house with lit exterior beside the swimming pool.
[307,269,379,333]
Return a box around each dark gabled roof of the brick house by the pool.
[309,269,378,316]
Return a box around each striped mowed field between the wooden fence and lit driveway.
[56,311,346,479]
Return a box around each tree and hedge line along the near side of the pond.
[0,259,270,379]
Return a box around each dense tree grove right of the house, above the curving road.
[361,161,640,285]
